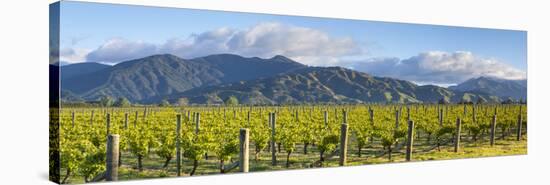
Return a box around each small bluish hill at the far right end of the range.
[449,77,527,100]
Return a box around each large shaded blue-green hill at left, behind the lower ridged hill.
[61,54,305,102]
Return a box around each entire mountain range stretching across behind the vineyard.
[60,54,527,104]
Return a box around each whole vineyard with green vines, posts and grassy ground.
[54,104,527,183]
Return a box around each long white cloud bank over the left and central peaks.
[78,23,362,66]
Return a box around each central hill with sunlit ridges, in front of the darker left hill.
[161,67,499,104]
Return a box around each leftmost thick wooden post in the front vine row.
[105,134,120,181]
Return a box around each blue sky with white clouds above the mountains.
[59,1,527,86]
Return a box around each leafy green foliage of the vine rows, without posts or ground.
[59,104,527,183]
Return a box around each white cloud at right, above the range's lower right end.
[351,51,527,84]
